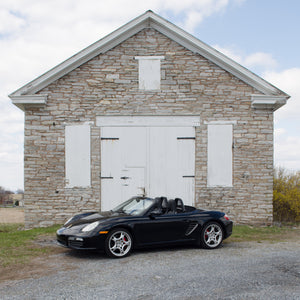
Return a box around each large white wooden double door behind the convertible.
[101,127,195,211]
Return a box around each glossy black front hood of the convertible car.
[65,211,128,227]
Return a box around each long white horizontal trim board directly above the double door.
[96,116,200,127]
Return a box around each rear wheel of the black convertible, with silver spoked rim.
[200,222,224,249]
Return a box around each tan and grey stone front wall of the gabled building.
[24,29,273,227]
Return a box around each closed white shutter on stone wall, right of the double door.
[207,124,232,187]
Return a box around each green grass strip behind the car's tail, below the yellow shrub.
[228,225,300,243]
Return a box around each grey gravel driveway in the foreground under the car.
[0,239,300,299]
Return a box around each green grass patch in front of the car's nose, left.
[0,224,60,267]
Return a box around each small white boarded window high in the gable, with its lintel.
[135,56,164,91]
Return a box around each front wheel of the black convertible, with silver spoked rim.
[105,228,133,258]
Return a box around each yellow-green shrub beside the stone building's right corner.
[273,168,300,223]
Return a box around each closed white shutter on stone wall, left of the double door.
[65,125,91,188]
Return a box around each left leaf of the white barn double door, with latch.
[101,127,147,211]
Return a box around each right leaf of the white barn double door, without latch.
[148,127,195,205]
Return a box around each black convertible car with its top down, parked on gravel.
[57,197,232,258]
